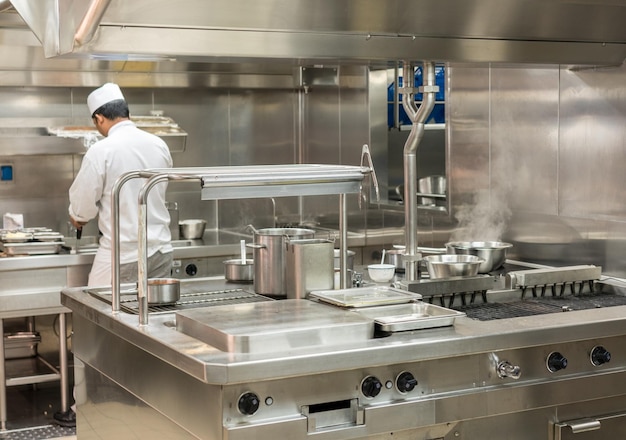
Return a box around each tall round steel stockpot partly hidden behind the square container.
[246,228,315,296]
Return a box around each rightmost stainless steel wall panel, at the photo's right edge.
[559,67,626,220]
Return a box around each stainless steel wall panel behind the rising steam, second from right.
[490,67,560,215]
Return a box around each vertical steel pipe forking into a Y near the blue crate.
[402,62,438,281]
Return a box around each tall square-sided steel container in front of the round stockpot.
[285,238,334,299]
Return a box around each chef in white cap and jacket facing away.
[69,83,172,286]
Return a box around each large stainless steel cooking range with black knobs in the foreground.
[62,261,626,439]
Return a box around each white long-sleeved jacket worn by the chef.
[69,120,172,286]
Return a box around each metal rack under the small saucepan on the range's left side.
[120,289,272,315]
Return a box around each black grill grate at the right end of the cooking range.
[453,293,626,321]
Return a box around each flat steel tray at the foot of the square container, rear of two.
[309,286,422,308]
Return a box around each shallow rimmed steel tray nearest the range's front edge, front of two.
[355,301,465,332]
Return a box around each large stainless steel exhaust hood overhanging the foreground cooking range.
[10,0,626,65]
